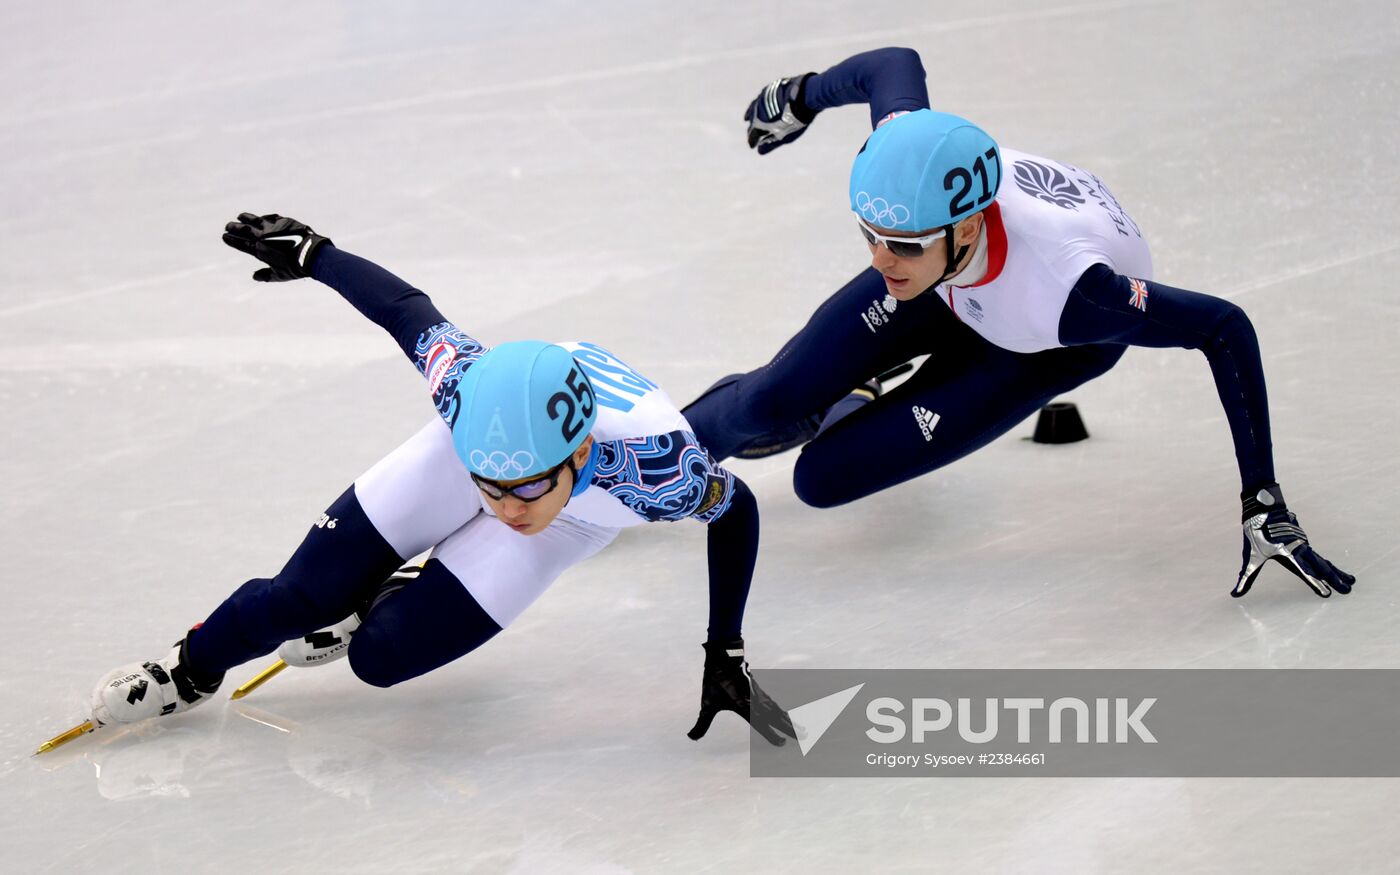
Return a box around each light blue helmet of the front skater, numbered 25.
[452,340,598,480]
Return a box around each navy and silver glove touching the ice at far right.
[1231,483,1357,598]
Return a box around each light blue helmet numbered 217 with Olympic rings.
[851,109,1001,231]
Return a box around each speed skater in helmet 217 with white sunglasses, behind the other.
[685,48,1355,596]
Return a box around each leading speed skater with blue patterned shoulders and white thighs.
[60,213,792,743]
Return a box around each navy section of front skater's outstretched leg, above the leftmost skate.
[189,487,403,675]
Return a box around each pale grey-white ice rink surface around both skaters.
[0,0,1400,872]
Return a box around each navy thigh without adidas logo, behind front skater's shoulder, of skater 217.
[683,269,946,459]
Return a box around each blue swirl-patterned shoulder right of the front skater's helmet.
[594,431,734,522]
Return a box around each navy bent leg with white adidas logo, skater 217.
[792,344,1126,507]
